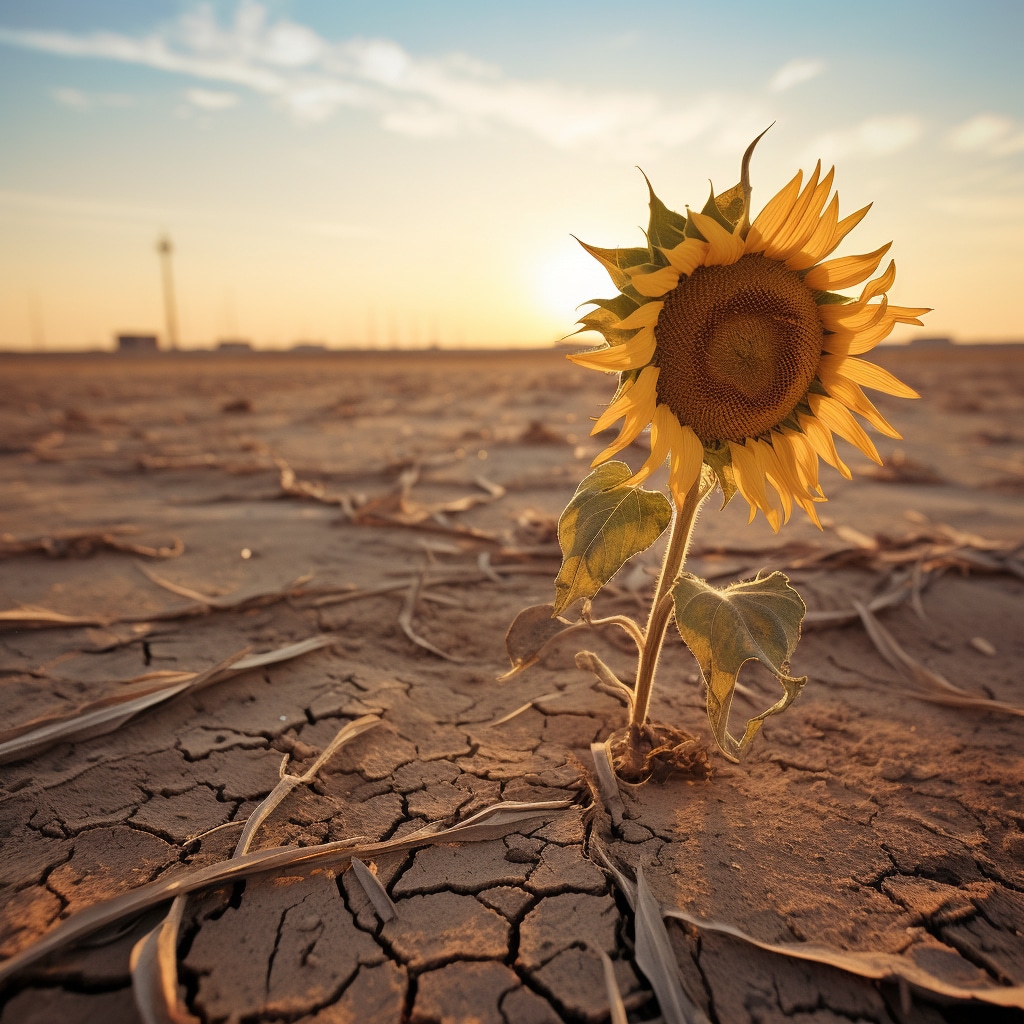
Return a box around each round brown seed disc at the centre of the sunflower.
[653,254,823,443]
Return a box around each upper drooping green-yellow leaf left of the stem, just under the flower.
[552,462,672,615]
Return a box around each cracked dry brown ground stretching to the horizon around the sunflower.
[0,348,1024,1024]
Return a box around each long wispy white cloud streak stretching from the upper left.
[0,0,753,159]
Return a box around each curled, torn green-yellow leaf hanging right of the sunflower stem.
[672,572,807,761]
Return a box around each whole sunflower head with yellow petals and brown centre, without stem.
[568,140,929,531]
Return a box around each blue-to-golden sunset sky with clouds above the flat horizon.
[0,0,1024,351]
